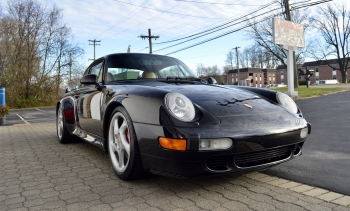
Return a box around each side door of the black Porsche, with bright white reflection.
[75,59,104,137]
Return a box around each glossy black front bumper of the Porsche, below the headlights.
[135,124,306,177]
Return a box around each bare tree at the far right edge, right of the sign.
[311,3,350,83]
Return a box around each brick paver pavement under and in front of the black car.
[0,123,350,211]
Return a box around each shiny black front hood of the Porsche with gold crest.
[154,85,307,137]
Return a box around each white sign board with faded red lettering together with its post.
[273,18,305,97]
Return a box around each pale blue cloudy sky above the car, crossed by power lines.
[0,0,347,70]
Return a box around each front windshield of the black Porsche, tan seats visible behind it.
[107,54,197,82]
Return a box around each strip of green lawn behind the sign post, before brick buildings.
[271,86,350,98]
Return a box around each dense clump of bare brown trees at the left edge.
[0,0,82,107]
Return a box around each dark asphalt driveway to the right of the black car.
[266,91,350,195]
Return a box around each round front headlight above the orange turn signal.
[164,93,195,122]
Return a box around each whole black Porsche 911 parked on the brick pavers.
[57,53,311,180]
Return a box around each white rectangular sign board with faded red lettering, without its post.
[273,18,305,48]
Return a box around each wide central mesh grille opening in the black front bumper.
[235,146,294,168]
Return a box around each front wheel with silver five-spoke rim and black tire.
[108,107,146,180]
